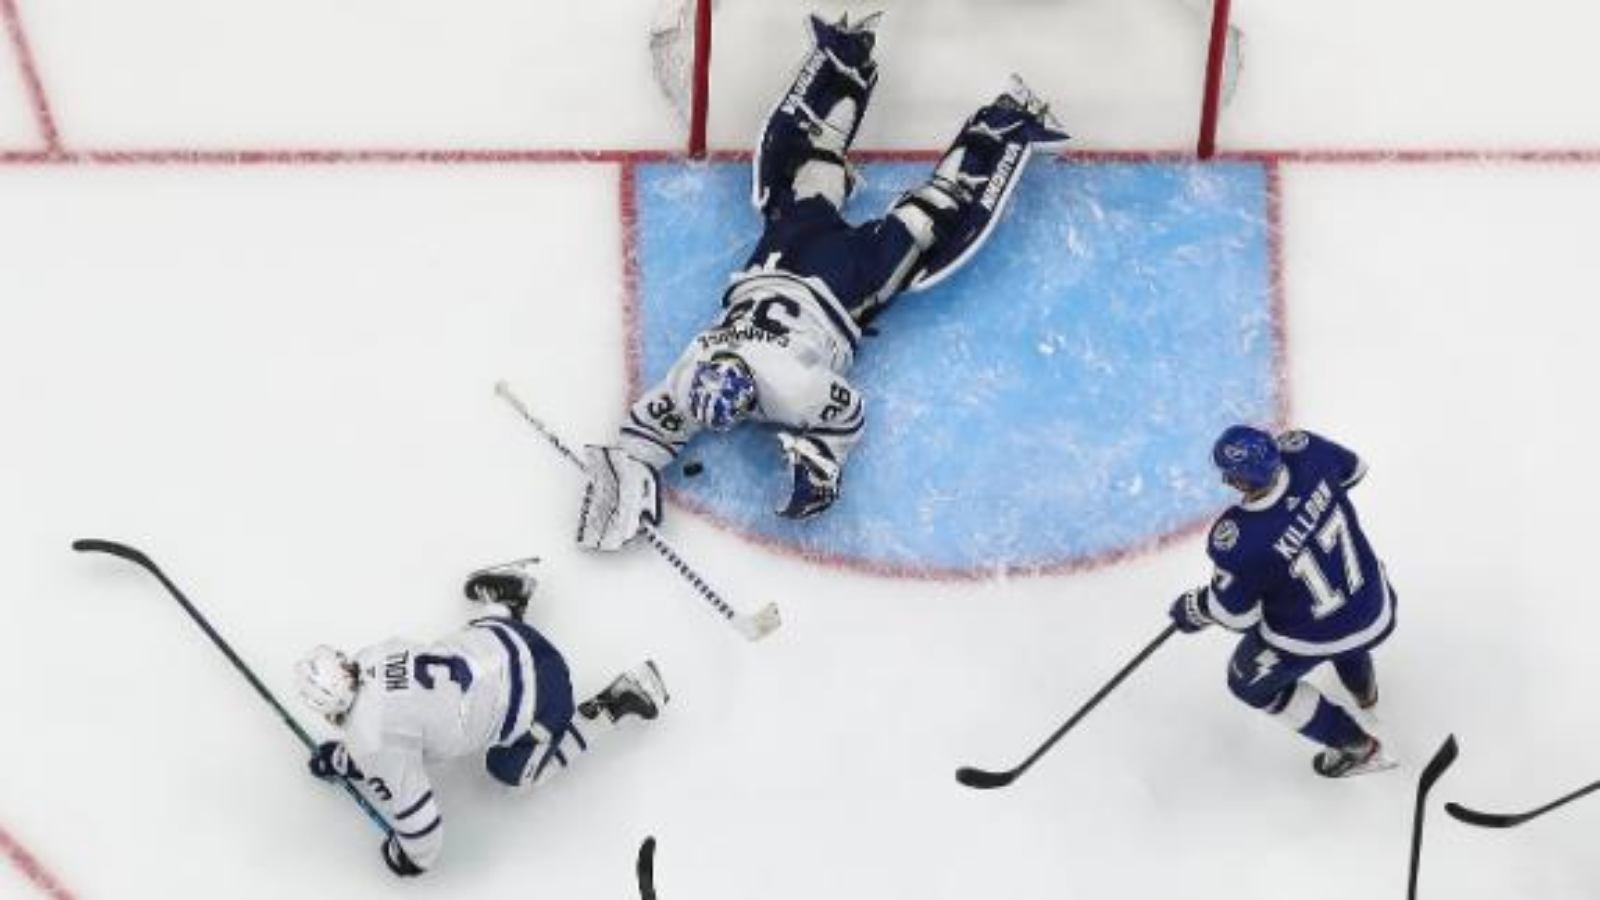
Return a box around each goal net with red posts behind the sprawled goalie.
[650,0,1243,157]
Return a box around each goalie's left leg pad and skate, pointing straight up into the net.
[750,13,880,211]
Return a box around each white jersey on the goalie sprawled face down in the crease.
[618,266,866,469]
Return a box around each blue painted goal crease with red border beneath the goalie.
[635,162,1280,570]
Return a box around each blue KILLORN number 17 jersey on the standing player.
[1202,431,1394,657]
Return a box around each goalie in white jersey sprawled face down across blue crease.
[578,14,1067,551]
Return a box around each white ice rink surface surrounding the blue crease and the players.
[0,0,1600,900]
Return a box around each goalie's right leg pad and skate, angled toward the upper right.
[893,75,1069,290]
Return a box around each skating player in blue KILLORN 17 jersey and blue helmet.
[1171,424,1395,778]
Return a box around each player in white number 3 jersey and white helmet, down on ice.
[296,564,667,876]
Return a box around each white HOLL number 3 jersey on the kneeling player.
[344,618,539,870]
